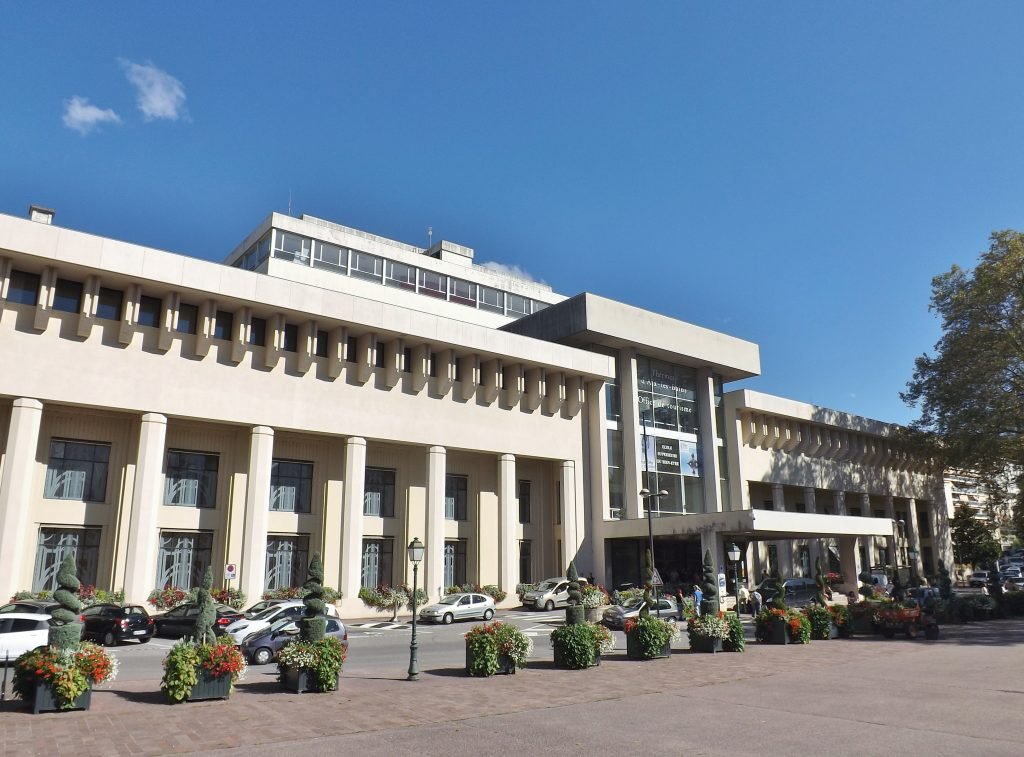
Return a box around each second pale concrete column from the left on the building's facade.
[124,413,167,603]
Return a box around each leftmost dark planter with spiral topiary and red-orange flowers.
[13,555,117,714]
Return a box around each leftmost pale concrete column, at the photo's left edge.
[0,398,43,601]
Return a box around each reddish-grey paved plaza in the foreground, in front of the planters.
[0,621,1024,757]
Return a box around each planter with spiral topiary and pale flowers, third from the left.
[278,552,345,693]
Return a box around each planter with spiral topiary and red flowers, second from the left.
[160,567,246,703]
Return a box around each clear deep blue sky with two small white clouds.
[0,1,1024,422]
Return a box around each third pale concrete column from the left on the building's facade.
[239,426,273,597]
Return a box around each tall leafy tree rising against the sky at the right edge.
[902,230,1024,511]
